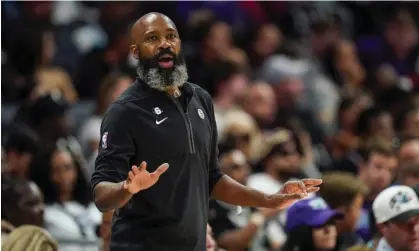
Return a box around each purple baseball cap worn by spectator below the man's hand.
[285,197,343,232]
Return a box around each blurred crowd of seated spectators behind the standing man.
[1,1,419,251]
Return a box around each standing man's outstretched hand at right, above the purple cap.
[271,179,322,209]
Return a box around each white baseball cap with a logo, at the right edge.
[372,185,419,223]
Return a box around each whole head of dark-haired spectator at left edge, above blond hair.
[1,174,44,231]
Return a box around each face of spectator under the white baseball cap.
[379,217,419,251]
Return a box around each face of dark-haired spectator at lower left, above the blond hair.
[5,182,44,227]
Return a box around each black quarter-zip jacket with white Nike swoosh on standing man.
[91,79,222,251]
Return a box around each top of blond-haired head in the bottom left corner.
[1,225,58,251]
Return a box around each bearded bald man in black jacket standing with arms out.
[91,13,321,251]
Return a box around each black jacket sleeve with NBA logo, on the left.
[91,103,135,194]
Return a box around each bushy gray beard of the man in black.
[137,64,189,91]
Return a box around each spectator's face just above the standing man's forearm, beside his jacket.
[220,150,250,185]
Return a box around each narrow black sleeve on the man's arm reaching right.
[207,94,224,194]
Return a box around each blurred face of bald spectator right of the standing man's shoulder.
[245,83,277,125]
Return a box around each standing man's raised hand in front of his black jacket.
[124,161,169,194]
